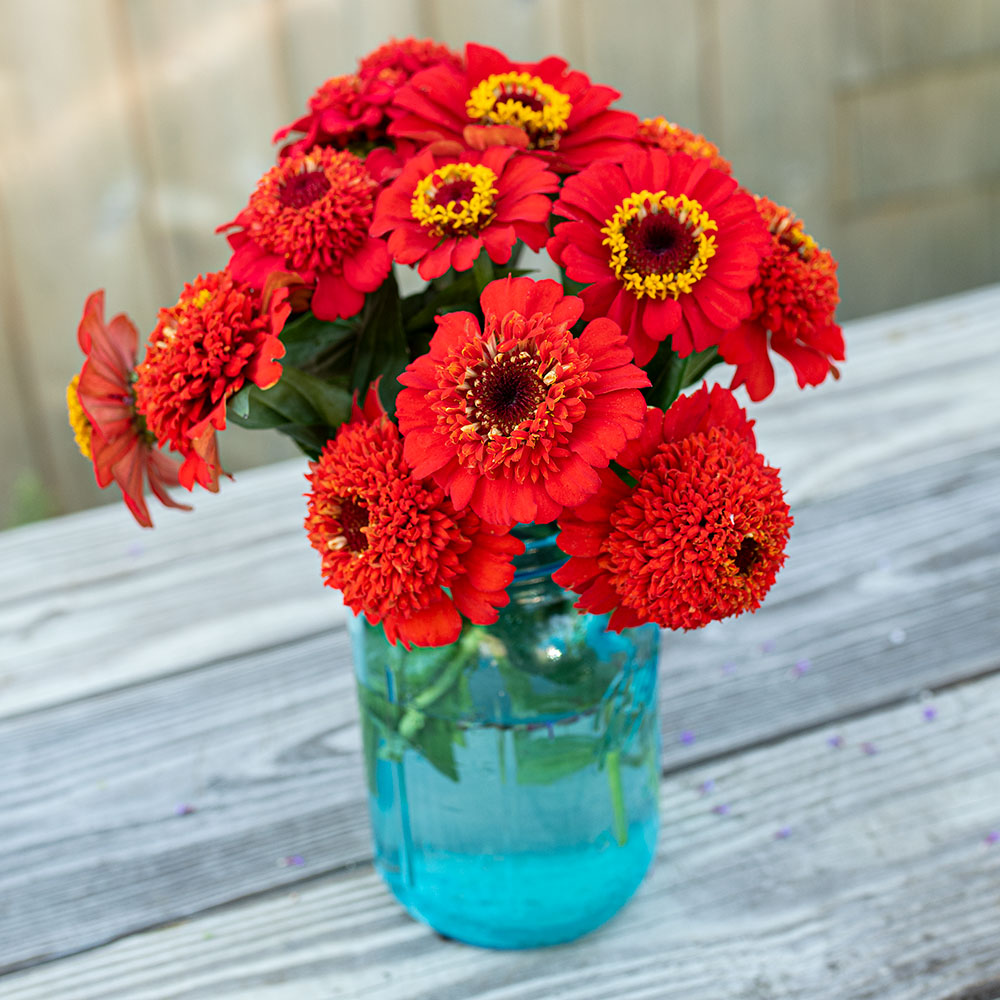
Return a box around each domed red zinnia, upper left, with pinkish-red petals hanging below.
[219,147,392,320]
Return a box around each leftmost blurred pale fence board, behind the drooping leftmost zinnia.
[0,0,164,509]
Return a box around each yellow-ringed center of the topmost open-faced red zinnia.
[465,72,573,148]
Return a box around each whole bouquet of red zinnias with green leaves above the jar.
[68,39,844,646]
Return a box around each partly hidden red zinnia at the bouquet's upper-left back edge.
[273,38,462,157]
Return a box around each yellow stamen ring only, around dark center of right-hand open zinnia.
[601,191,719,299]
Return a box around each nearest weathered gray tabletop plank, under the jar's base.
[4,664,1000,1000]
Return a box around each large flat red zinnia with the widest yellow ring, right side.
[548,149,771,365]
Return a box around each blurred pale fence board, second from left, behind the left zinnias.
[114,0,298,480]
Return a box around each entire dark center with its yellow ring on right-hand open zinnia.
[601,191,719,299]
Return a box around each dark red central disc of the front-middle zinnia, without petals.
[465,351,548,437]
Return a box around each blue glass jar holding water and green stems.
[351,531,659,948]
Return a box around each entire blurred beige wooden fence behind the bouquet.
[0,0,1000,525]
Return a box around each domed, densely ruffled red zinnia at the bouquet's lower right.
[552,386,792,631]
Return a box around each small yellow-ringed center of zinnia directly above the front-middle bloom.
[410,163,497,236]
